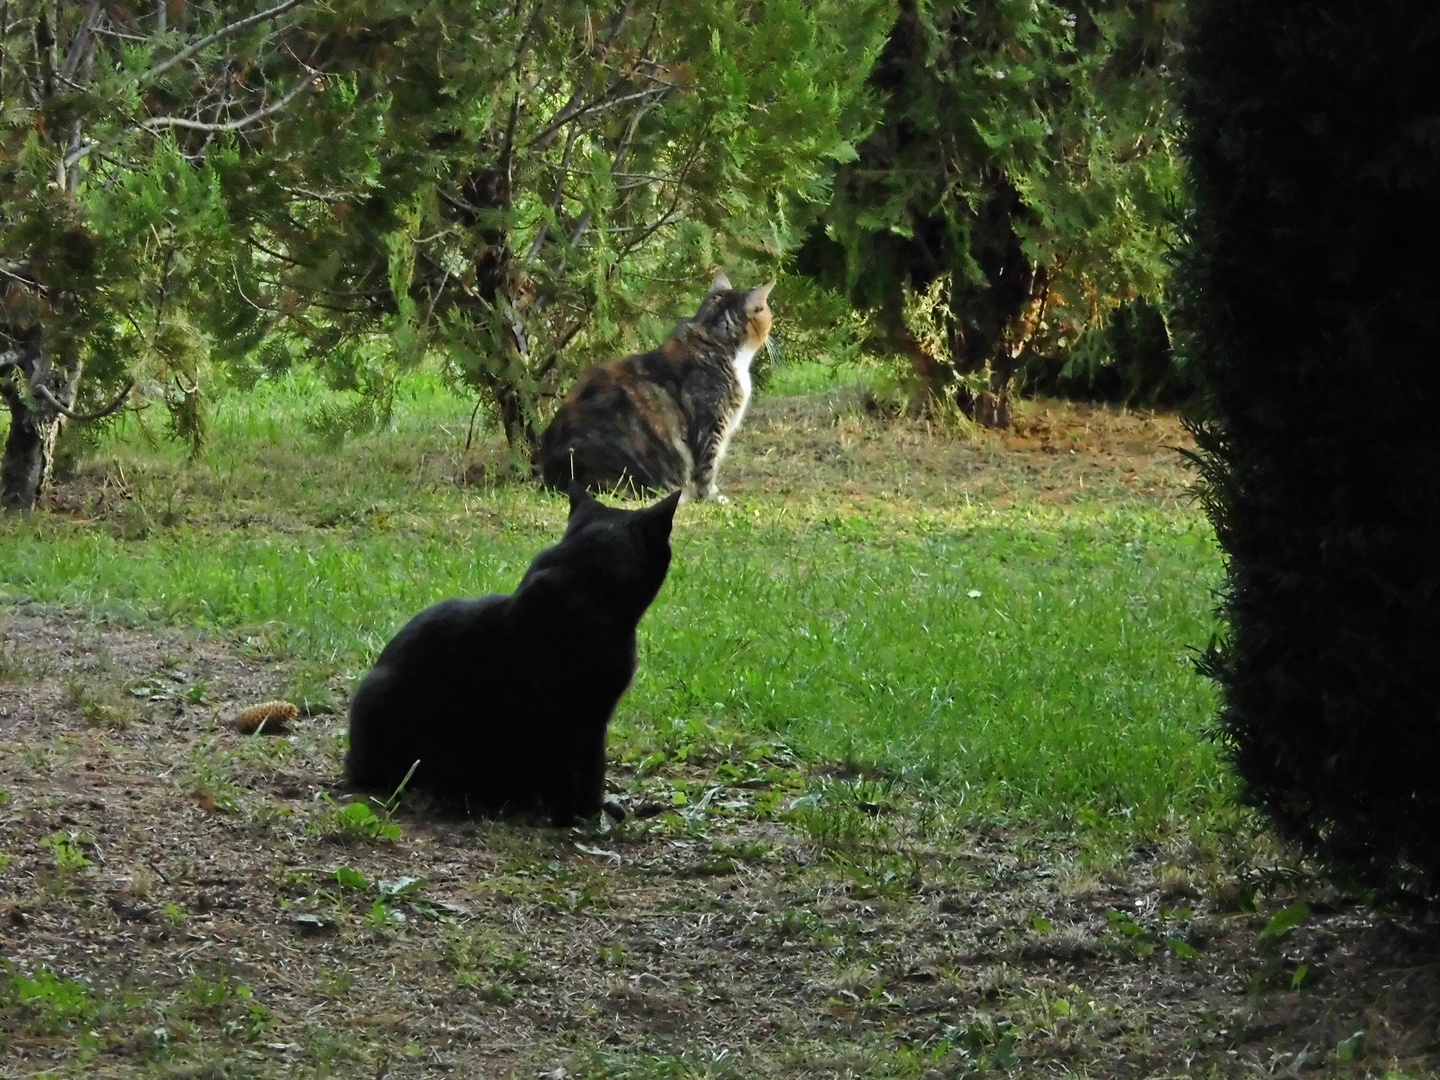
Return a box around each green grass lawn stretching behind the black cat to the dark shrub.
[0,379,1227,829]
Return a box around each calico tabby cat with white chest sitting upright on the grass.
[539,274,775,503]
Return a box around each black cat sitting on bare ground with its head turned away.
[346,485,680,825]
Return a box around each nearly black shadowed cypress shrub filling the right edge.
[1185,0,1440,900]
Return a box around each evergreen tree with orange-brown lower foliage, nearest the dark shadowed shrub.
[801,0,1178,426]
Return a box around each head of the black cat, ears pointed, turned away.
[520,484,680,619]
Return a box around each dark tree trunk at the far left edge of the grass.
[0,327,81,510]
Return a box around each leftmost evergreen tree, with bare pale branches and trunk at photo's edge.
[0,0,327,508]
